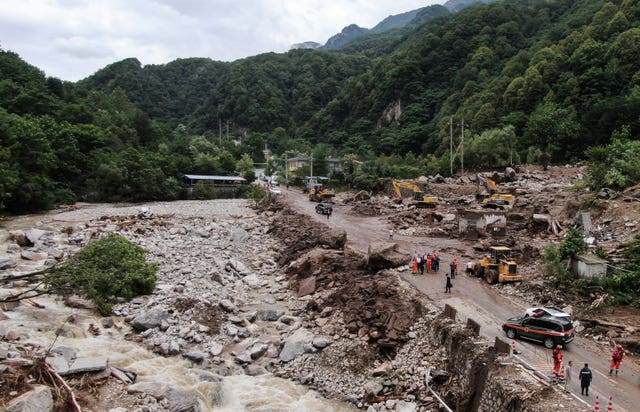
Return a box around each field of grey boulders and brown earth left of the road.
[0,200,460,411]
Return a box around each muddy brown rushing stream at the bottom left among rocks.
[0,290,356,412]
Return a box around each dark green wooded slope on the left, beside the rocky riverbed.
[0,49,253,213]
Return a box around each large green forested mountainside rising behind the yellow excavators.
[82,0,640,164]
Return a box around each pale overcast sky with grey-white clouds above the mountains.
[0,0,445,81]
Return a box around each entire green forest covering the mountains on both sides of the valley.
[0,0,640,212]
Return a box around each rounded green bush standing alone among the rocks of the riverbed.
[45,234,158,316]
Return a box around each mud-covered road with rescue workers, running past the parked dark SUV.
[282,189,640,411]
